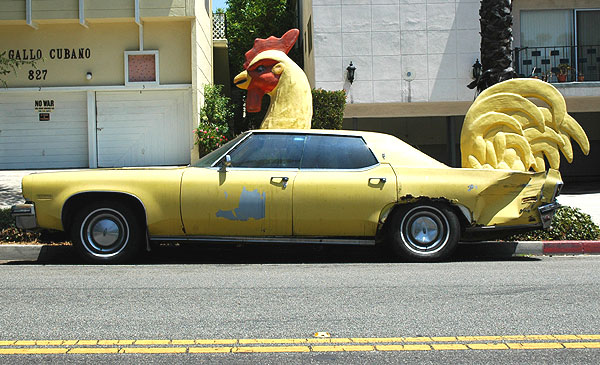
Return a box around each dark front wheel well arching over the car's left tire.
[61,192,146,232]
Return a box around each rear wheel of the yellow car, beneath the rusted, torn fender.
[388,202,460,262]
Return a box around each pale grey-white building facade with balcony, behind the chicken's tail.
[302,0,600,178]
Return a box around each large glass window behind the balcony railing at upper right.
[514,9,600,81]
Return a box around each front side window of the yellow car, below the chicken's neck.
[230,133,306,169]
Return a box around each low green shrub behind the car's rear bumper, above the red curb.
[506,206,600,241]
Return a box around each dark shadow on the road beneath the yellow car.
[4,243,539,265]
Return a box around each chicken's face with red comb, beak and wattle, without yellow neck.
[233,29,300,113]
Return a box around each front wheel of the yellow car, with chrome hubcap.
[71,201,144,264]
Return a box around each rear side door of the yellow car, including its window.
[293,135,397,236]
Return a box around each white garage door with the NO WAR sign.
[0,92,88,170]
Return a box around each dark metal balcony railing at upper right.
[513,45,600,82]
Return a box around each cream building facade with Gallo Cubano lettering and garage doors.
[0,0,213,169]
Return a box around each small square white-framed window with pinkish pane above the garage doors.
[125,51,159,86]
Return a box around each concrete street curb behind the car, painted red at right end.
[0,241,600,263]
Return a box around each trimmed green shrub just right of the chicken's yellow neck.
[312,89,346,129]
